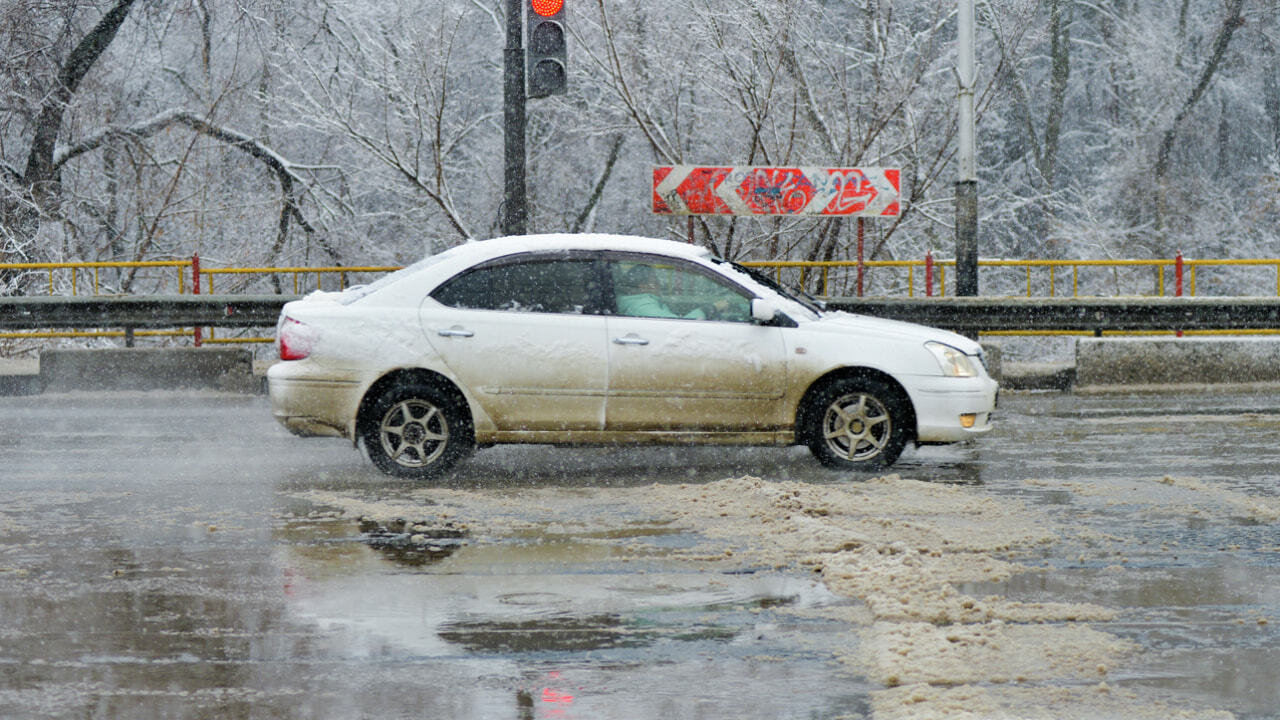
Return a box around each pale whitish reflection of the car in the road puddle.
[283,515,841,656]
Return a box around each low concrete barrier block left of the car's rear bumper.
[40,347,261,392]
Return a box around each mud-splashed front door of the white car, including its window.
[605,254,786,432]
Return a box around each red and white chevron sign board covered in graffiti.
[653,165,901,218]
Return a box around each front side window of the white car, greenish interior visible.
[608,259,751,323]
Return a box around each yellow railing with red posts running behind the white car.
[0,254,1280,343]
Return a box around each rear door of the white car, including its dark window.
[420,254,608,432]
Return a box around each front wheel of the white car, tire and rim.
[797,378,910,470]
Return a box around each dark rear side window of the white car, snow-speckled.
[431,259,598,314]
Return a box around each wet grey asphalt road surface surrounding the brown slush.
[0,393,1280,719]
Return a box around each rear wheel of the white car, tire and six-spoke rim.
[360,383,475,480]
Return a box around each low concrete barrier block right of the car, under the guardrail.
[1075,336,1280,386]
